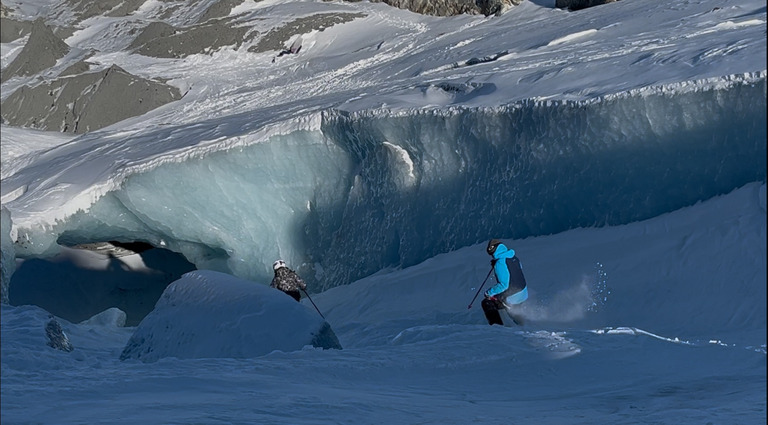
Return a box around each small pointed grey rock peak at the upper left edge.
[0,19,69,82]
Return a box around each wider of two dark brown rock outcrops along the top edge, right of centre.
[352,0,523,16]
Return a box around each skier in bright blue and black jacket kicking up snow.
[481,239,528,325]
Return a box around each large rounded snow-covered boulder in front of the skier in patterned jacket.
[120,270,341,362]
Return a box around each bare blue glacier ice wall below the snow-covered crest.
[49,74,766,290]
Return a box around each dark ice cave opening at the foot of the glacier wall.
[8,240,196,326]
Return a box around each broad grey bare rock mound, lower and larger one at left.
[2,65,181,133]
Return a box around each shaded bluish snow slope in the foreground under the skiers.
[1,184,766,424]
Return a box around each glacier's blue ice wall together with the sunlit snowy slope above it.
[1,0,766,302]
